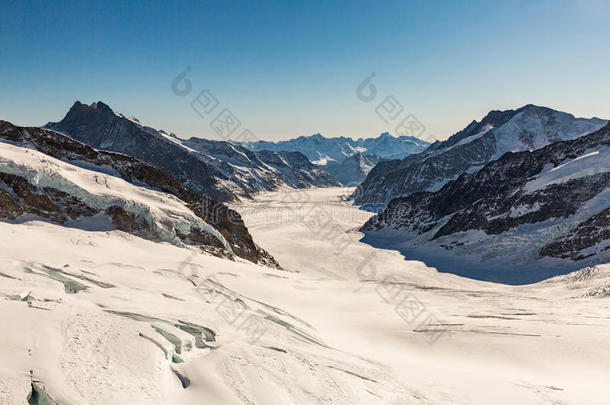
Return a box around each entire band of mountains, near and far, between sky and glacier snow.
[0,102,610,283]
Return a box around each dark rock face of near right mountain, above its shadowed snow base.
[362,125,610,268]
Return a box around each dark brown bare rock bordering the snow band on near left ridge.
[0,121,279,267]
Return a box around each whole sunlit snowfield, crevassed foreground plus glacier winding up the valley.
[0,189,610,405]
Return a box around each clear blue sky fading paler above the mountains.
[0,0,610,140]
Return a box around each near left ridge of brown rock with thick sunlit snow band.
[0,121,277,267]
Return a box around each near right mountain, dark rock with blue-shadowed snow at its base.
[362,121,610,282]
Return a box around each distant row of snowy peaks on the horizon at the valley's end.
[243,132,430,165]
